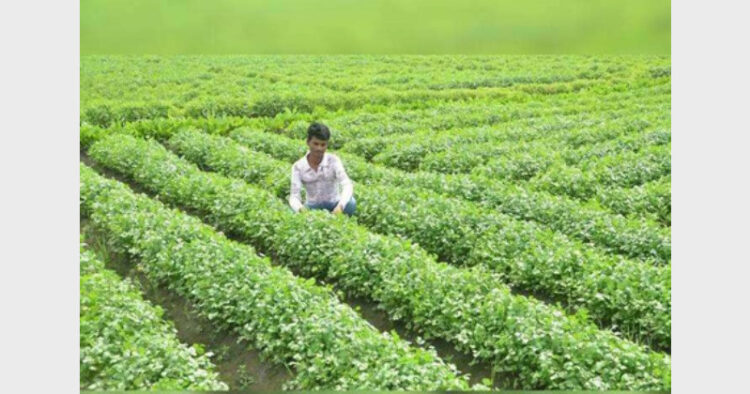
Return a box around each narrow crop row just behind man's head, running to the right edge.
[274,86,669,148]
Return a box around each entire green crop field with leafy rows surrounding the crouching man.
[80,56,672,391]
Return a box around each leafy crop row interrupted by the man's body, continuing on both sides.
[168,131,671,349]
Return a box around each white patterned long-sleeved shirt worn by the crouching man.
[289,151,354,212]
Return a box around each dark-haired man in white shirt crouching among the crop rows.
[289,123,356,216]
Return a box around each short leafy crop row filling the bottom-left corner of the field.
[80,240,228,391]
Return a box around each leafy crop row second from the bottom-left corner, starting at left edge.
[81,165,476,390]
